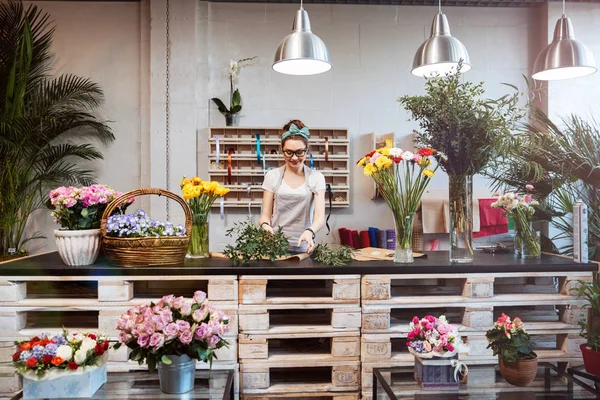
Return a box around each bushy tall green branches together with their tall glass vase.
[398,62,530,263]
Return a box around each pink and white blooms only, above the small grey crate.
[406,315,466,358]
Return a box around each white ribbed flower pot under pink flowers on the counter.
[54,229,100,266]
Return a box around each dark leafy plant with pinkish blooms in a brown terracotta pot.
[485,314,538,386]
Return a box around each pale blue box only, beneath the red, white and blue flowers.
[23,364,107,399]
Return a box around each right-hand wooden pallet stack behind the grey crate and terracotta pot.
[361,272,590,399]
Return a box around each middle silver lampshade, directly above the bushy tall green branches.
[411,11,471,76]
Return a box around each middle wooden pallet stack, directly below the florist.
[239,275,361,400]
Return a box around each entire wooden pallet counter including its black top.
[0,252,598,400]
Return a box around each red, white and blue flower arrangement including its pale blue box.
[12,330,109,399]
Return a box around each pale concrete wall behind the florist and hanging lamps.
[22,0,600,250]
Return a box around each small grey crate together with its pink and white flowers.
[406,315,468,390]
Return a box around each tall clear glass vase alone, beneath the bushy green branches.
[448,175,473,263]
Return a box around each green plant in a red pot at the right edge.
[572,272,600,376]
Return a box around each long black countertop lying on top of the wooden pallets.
[0,251,598,278]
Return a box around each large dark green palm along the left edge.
[0,0,114,259]
